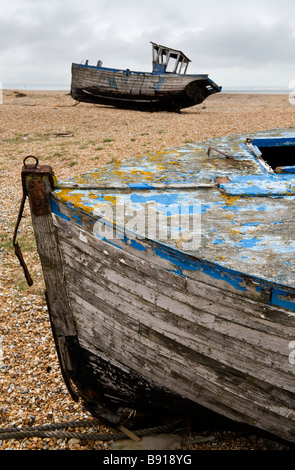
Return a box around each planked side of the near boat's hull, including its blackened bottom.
[44,197,295,441]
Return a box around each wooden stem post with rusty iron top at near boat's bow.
[14,156,126,425]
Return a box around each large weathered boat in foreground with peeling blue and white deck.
[14,128,295,442]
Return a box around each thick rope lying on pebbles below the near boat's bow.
[0,419,175,441]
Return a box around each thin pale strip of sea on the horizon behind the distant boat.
[0,82,294,95]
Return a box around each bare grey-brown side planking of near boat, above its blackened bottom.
[48,211,294,442]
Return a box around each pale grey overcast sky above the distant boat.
[0,0,295,89]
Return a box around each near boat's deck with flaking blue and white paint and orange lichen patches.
[52,129,295,292]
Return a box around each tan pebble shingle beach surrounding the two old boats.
[0,90,294,450]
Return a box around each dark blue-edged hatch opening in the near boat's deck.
[252,138,295,173]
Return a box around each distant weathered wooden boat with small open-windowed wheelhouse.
[71,43,221,111]
